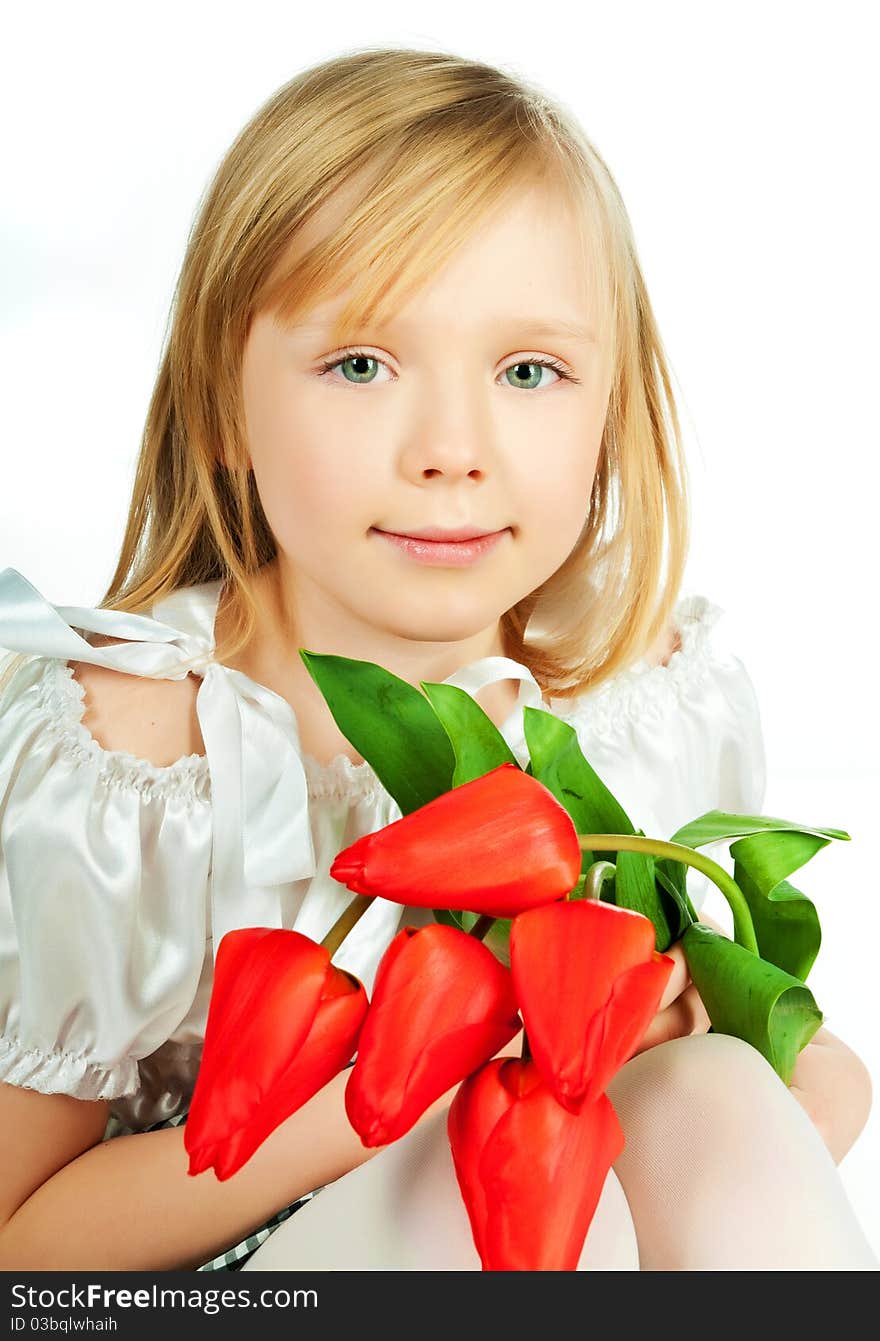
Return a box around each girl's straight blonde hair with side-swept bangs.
[101,47,690,697]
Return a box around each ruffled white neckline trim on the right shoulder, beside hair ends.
[557,595,724,736]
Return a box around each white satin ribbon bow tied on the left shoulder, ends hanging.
[0,569,315,961]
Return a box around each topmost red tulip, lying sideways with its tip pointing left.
[330,763,581,917]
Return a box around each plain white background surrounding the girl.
[0,0,880,1252]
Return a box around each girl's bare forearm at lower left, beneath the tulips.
[0,1069,455,1271]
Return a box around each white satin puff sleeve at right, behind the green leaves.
[554,595,766,909]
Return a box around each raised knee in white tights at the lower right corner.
[608,1034,880,1271]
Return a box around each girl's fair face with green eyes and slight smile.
[243,178,612,664]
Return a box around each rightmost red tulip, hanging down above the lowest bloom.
[510,898,675,1113]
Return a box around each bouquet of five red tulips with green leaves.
[185,650,849,1270]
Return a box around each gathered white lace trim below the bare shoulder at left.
[36,657,211,806]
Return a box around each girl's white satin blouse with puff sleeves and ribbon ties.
[0,569,766,1130]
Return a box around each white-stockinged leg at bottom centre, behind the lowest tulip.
[241,1094,639,1271]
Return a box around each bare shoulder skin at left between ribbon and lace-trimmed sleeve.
[70,634,205,767]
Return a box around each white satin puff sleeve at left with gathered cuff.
[0,650,212,1100]
